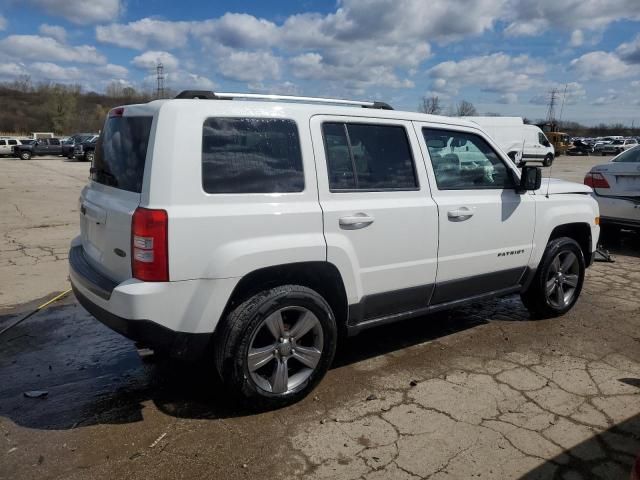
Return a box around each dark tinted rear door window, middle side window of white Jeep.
[322,123,418,190]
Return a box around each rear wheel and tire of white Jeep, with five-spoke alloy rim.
[214,285,338,410]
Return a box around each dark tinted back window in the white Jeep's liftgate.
[91,117,152,193]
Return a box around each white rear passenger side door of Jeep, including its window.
[311,116,438,323]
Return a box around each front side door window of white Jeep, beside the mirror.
[422,128,514,190]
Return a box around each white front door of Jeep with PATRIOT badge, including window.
[416,123,535,304]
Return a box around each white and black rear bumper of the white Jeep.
[69,246,236,358]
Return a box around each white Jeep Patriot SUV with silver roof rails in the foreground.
[69,92,599,407]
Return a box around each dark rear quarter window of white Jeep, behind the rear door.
[202,118,304,193]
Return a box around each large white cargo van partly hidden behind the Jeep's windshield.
[465,117,555,167]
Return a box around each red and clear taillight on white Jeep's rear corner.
[131,207,169,282]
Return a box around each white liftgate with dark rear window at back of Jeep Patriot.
[80,109,153,281]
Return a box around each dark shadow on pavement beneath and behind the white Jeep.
[0,298,504,430]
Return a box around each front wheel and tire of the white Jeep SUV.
[520,237,585,318]
